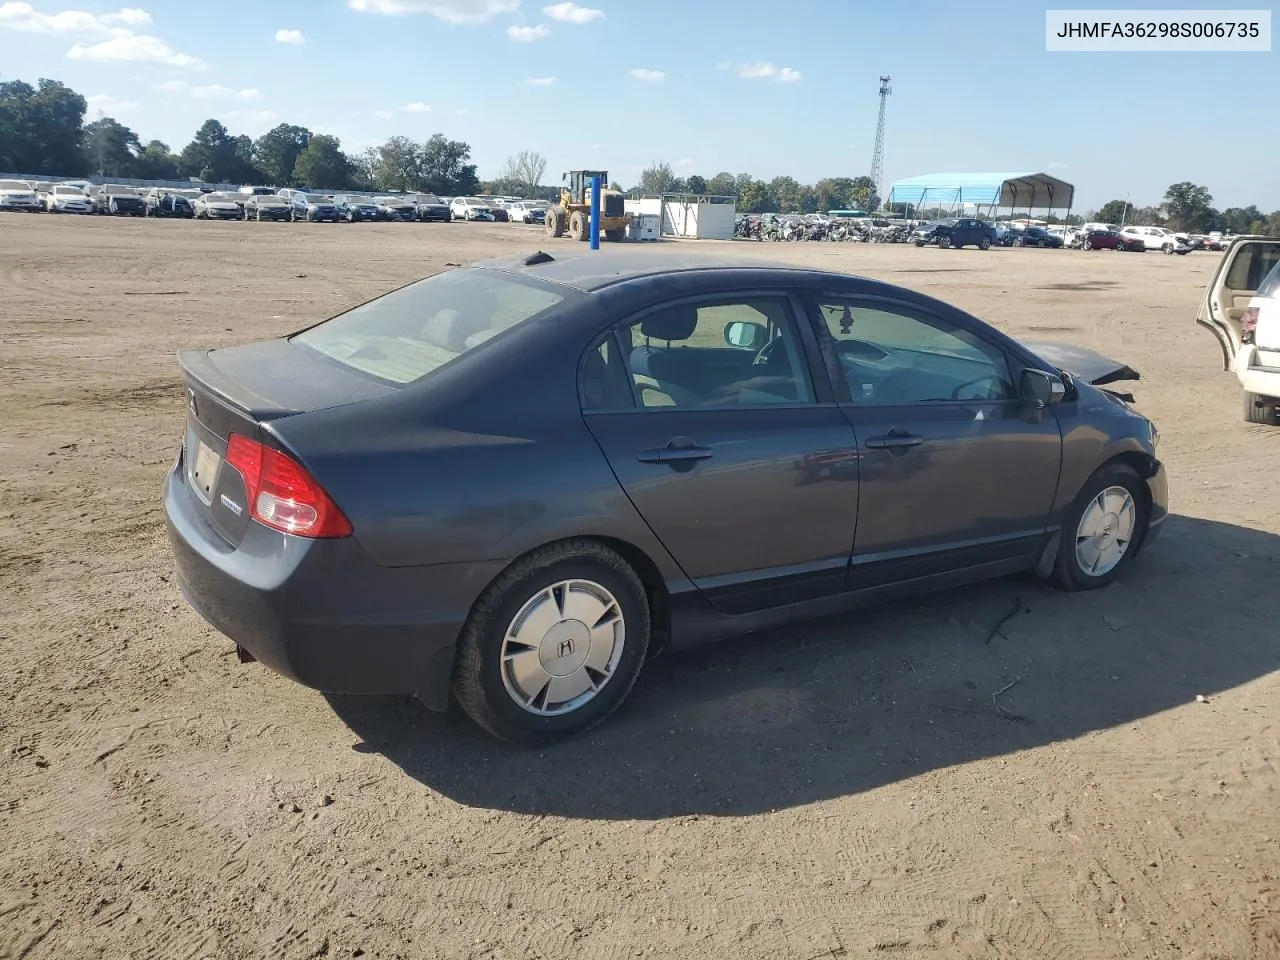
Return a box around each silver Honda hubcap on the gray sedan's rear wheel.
[502,580,626,717]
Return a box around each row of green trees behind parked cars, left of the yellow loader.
[0,79,481,195]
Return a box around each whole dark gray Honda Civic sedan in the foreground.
[164,248,1167,744]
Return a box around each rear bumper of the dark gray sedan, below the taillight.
[164,460,502,709]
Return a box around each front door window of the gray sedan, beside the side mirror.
[818,298,1018,404]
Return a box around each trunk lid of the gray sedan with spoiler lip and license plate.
[178,339,396,547]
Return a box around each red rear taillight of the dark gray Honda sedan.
[227,434,351,538]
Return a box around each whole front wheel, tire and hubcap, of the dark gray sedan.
[1051,465,1147,590]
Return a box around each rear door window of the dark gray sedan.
[622,296,813,408]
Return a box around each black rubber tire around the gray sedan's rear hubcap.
[453,540,650,746]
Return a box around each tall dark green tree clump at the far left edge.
[0,79,87,175]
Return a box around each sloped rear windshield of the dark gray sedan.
[293,269,564,384]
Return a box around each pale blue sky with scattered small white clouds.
[0,0,1280,211]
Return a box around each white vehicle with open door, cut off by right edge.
[1196,237,1280,425]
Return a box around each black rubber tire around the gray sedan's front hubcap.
[1050,463,1147,590]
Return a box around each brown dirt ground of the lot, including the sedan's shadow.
[0,215,1280,960]
